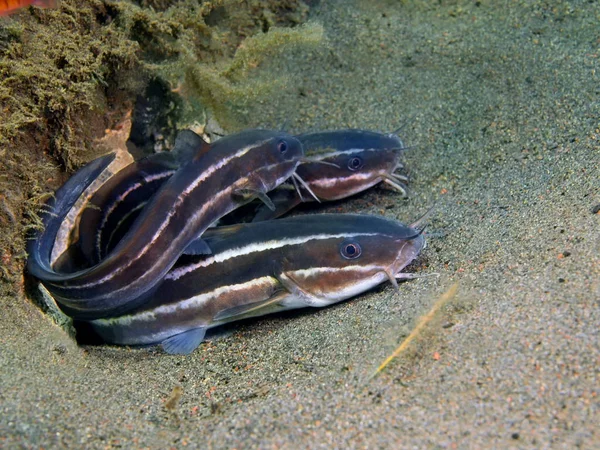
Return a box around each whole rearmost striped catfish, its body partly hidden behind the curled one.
[67,129,407,258]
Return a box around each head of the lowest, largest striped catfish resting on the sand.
[283,215,425,306]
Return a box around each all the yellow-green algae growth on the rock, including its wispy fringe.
[0,0,322,292]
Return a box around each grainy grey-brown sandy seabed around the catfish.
[0,1,600,448]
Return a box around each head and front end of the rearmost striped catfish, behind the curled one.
[253,129,408,222]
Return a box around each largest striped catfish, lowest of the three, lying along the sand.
[86,214,425,354]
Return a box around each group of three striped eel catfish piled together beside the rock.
[27,129,425,354]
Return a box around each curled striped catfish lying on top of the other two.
[28,130,303,319]
